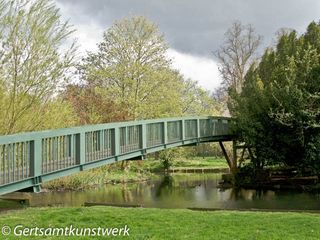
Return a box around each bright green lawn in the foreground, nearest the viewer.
[0,207,320,240]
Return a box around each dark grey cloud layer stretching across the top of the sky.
[56,0,320,57]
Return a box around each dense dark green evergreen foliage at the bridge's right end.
[233,22,320,173]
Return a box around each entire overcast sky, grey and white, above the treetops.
[55,0,320,91]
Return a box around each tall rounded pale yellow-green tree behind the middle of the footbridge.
[79,17,183,120]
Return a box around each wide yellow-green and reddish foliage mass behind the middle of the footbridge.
[63,16,219,124]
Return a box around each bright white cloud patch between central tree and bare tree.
[168,49,221,91]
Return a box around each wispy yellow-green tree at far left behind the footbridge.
[0,0,76,134]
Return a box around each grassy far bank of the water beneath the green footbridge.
[42,157,228,190]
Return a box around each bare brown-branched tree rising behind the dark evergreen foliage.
[215,22,261,94]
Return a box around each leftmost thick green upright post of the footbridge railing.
[30,139,42,177]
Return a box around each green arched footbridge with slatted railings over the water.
[0,117,232,195]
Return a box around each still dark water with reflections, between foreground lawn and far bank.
[0,174,320,210]
